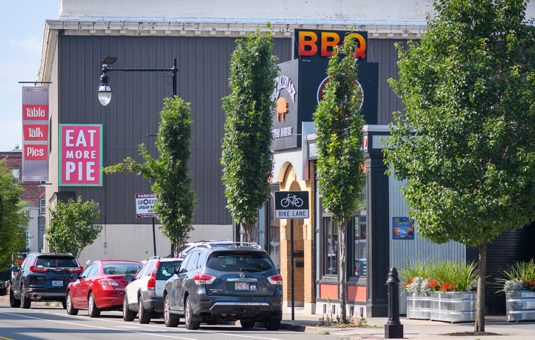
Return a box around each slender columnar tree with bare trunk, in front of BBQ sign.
[314,39,365,323]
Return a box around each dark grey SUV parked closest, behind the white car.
[164,243,282,330]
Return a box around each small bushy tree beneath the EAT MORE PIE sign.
[46,196,102,257]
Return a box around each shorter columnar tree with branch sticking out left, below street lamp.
[105,96,195,256]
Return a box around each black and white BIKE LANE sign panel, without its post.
[275,191,309,219]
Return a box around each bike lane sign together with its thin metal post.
[275,191,309,320]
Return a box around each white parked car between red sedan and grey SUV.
[123,257,182,323]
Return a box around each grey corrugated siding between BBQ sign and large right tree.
[368,39,406,125]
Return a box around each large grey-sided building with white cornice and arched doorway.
[40,0,535,316]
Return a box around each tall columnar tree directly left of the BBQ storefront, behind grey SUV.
[221,31,278,242]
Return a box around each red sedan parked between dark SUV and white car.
[65,260,141,318]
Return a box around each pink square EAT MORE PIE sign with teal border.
[59,124,103,186]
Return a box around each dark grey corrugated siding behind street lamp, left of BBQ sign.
[58,36,291,224]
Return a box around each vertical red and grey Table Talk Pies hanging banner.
[22,86,48,181]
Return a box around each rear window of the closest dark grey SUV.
[206,250,273,272]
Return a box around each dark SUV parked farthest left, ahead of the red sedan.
[9,253,82,308]
